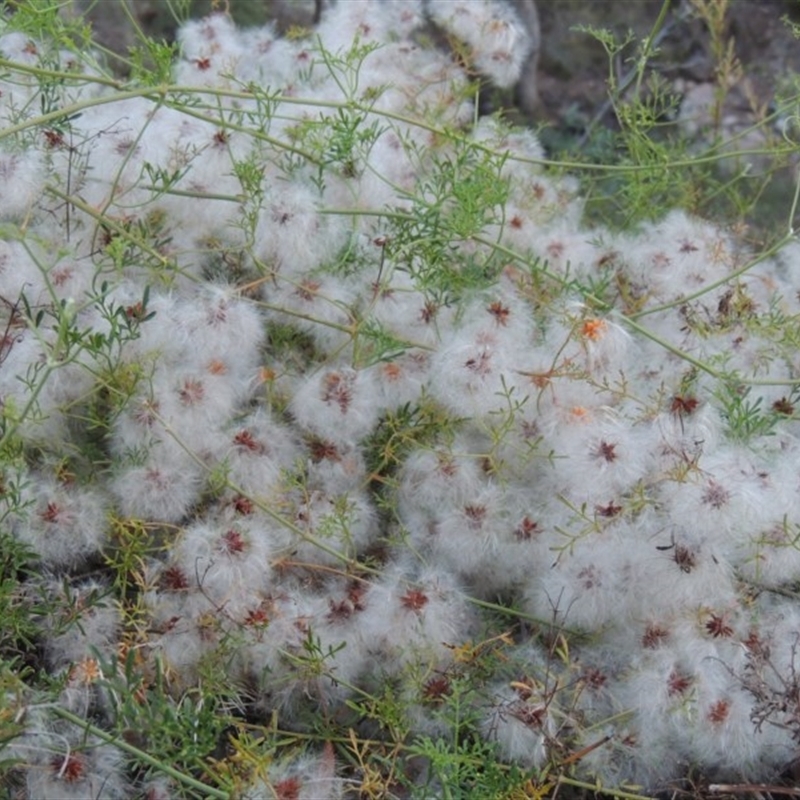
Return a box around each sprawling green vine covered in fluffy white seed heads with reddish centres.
[0,0,800,800]
